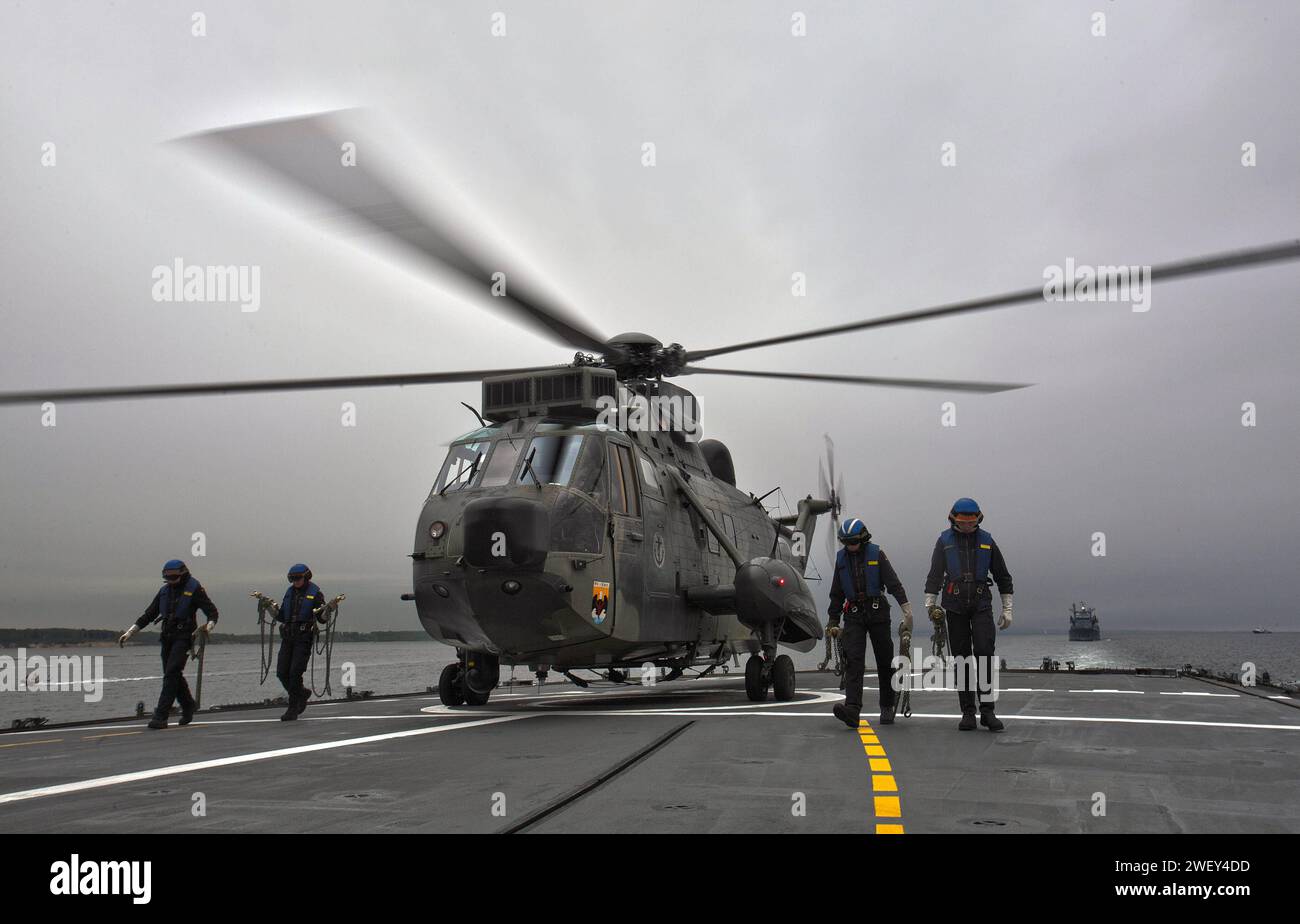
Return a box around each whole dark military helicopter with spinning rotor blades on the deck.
[0,113,1300,704]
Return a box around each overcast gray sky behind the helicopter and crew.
[0,0,1300,632]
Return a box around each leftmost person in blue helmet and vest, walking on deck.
[117,559,217,728]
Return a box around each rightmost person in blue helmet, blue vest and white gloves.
[926,498,1011,732]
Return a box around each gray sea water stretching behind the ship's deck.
[0,631,1300,728]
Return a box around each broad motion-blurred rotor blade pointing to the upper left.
[178,113,607,353]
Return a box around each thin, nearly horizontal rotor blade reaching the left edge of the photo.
[0,366,563,404]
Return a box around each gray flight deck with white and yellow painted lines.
[0,672,1300,833]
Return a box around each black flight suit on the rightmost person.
[926,529,1013,715]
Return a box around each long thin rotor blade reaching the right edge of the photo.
[686,240,1300,363]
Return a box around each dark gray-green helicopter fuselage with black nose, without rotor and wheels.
[412,417,822,671]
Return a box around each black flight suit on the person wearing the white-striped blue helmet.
[827,545,907,716]
